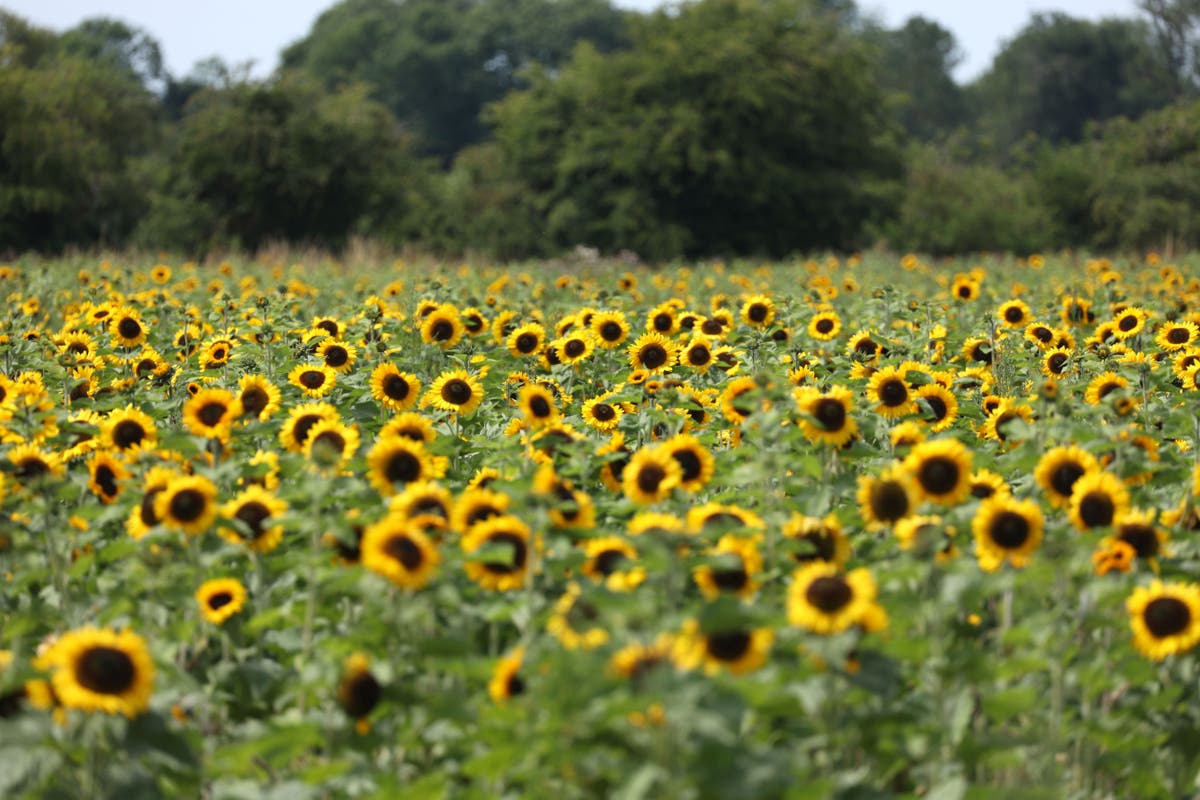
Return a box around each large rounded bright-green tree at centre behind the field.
[477,0,900,259]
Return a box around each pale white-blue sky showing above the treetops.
[0,0,1136,82]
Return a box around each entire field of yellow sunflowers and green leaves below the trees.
[0,254,1200,800]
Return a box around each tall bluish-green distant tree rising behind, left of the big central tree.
[283,0,625,161]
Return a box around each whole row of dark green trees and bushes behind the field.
[0,0,1200,260]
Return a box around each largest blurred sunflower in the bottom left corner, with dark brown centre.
[38,627,155,718]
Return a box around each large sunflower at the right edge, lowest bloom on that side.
[1126,581,1200,661]
